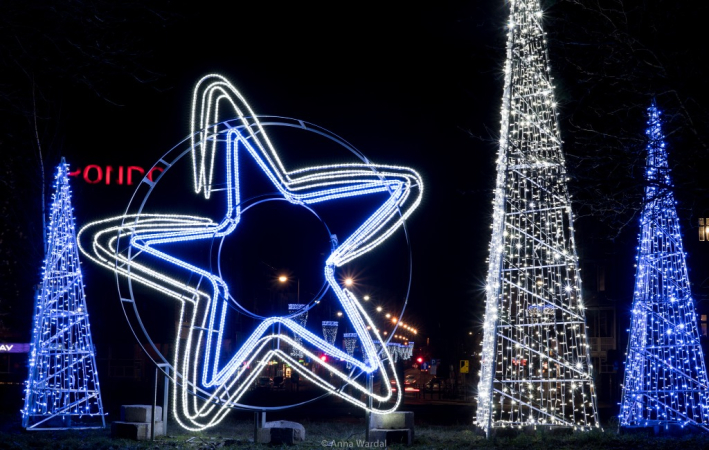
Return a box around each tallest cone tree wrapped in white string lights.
[475,0,599,435]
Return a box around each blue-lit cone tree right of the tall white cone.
[620,102,709,431]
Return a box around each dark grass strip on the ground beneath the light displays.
[0,418,709,450]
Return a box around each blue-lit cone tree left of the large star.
[22,159,105,430]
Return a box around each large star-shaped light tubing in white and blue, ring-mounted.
[81,75,423,429]
